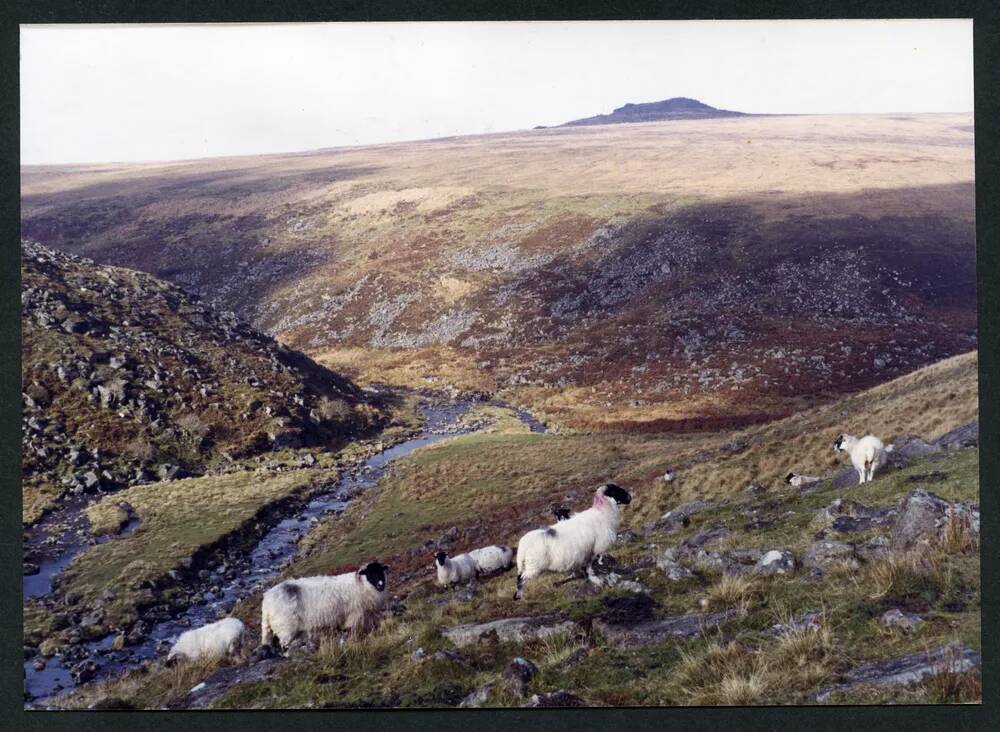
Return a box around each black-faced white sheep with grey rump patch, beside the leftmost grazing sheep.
[260,562,389,649]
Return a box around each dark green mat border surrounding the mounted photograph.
[0,0,1000,732]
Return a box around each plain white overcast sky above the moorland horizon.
[21,20,973,164]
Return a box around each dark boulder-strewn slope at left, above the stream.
[21,241,379,522]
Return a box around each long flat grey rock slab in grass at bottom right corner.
[812,641,982,702]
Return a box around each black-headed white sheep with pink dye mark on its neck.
[514,483,632,600]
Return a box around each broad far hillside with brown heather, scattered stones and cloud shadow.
[22,114,976,431]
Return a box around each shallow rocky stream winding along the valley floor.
[23,400,546,702]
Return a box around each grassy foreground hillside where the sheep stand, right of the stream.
[52,353,981,708]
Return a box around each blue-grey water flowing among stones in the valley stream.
[24,401,545,699]
